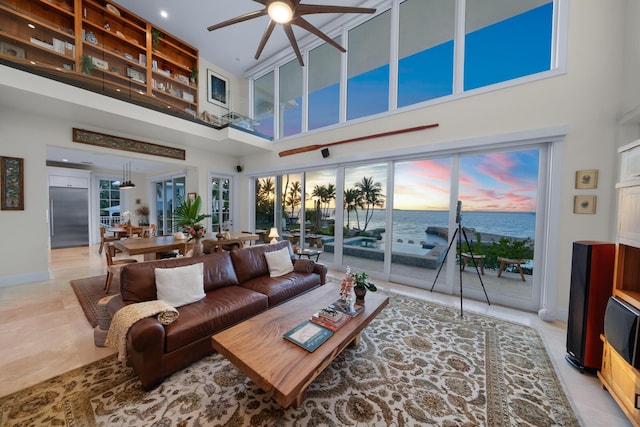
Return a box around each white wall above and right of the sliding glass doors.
[239,1,624,317]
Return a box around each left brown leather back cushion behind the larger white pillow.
[120,252,238,303]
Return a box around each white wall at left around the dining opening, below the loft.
[0,98,238,286]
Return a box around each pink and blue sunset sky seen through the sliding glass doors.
[298,150,539,212]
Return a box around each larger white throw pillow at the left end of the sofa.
[155,262,204,307]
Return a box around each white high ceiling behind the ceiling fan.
[115,0,380,76]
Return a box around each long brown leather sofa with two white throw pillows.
[107,241,327,389]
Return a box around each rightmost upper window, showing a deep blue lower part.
[464,0,553,90]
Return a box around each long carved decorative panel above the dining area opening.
[73,128,185,160]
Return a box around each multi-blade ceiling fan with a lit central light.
[207,0,376,66]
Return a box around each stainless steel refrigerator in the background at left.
[49,187,89,249]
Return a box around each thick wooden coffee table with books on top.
[212,283,389,408]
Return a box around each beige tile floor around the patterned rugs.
[0,246,631,427]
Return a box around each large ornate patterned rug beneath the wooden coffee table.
[0,295,579,426]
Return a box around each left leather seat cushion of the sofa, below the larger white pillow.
[165,286,268,353]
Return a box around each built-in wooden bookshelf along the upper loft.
[0,0,199,118]
